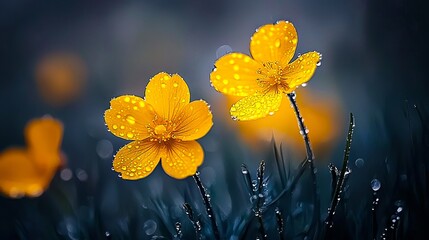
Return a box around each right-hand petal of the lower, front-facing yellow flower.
[173,100,213,141]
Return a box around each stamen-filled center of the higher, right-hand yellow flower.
[256,62,289,92]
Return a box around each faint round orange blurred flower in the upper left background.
[35,52,86,107]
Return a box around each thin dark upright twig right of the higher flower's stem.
[325,113,355,237]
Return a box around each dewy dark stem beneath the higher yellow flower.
[287,92,320,230]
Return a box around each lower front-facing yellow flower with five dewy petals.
[104,73,213,180]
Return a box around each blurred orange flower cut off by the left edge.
[0,117,63,198]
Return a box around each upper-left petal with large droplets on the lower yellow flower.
[104,95,155,140]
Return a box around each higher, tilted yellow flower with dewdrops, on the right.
[210,21,321,120]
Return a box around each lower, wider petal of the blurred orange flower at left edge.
[0,148,50,198]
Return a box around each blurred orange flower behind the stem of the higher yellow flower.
[224,89,342,154]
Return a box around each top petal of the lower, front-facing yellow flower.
[145,73,190,120]
